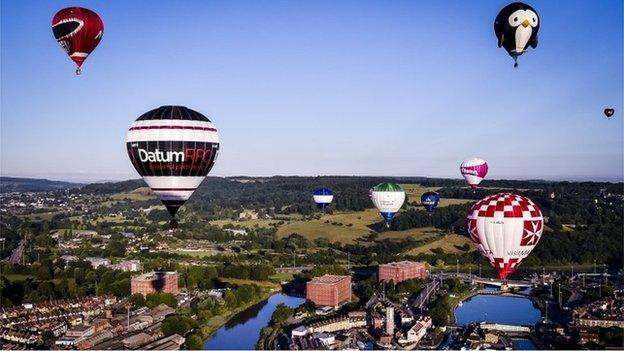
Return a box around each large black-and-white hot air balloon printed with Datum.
[126,106,219,228]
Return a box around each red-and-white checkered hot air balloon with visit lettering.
[467,193,544,288]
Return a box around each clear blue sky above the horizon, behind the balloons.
[0,0,624,181]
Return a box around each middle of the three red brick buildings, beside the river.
[306,275,351,307]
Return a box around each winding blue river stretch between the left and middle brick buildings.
[204,293,305,350]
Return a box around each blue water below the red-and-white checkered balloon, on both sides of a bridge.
[455,295,541,350]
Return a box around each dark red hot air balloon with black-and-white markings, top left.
[52,7,104,74]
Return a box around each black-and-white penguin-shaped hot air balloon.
[494,2,540,67]
